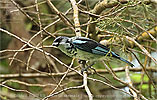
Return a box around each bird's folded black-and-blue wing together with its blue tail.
[72,37,134,67]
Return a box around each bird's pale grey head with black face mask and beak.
[52,36,68,47]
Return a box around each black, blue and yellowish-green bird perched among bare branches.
[52,36,134,67]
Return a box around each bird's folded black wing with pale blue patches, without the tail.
[72,37,110,56]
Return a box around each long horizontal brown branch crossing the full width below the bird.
[0,67,157,79]
